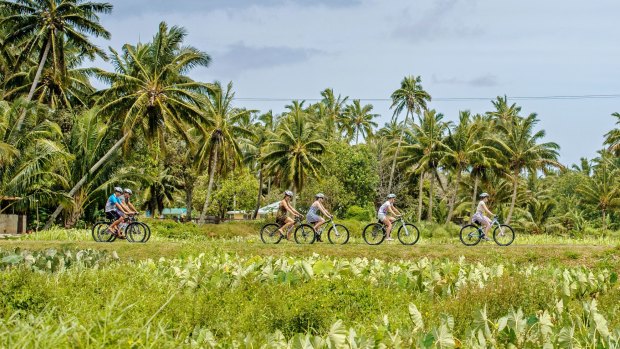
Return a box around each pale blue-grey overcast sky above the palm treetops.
[92,0,620,164]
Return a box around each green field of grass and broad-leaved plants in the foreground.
[0,223,620,348]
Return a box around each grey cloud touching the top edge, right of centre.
[393,0,483,42]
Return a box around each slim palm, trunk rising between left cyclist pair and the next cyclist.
[199,82,249,223]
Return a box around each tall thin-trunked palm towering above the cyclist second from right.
[388,75,431,191]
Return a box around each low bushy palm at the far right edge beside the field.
[577,150,620,231]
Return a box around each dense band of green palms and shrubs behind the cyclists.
[0,0,620,236]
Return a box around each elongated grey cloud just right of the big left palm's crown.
[211,42,322,76]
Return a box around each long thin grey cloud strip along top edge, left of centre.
[110,0,362,17]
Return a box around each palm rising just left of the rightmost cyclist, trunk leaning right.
[440,111,492,224]
